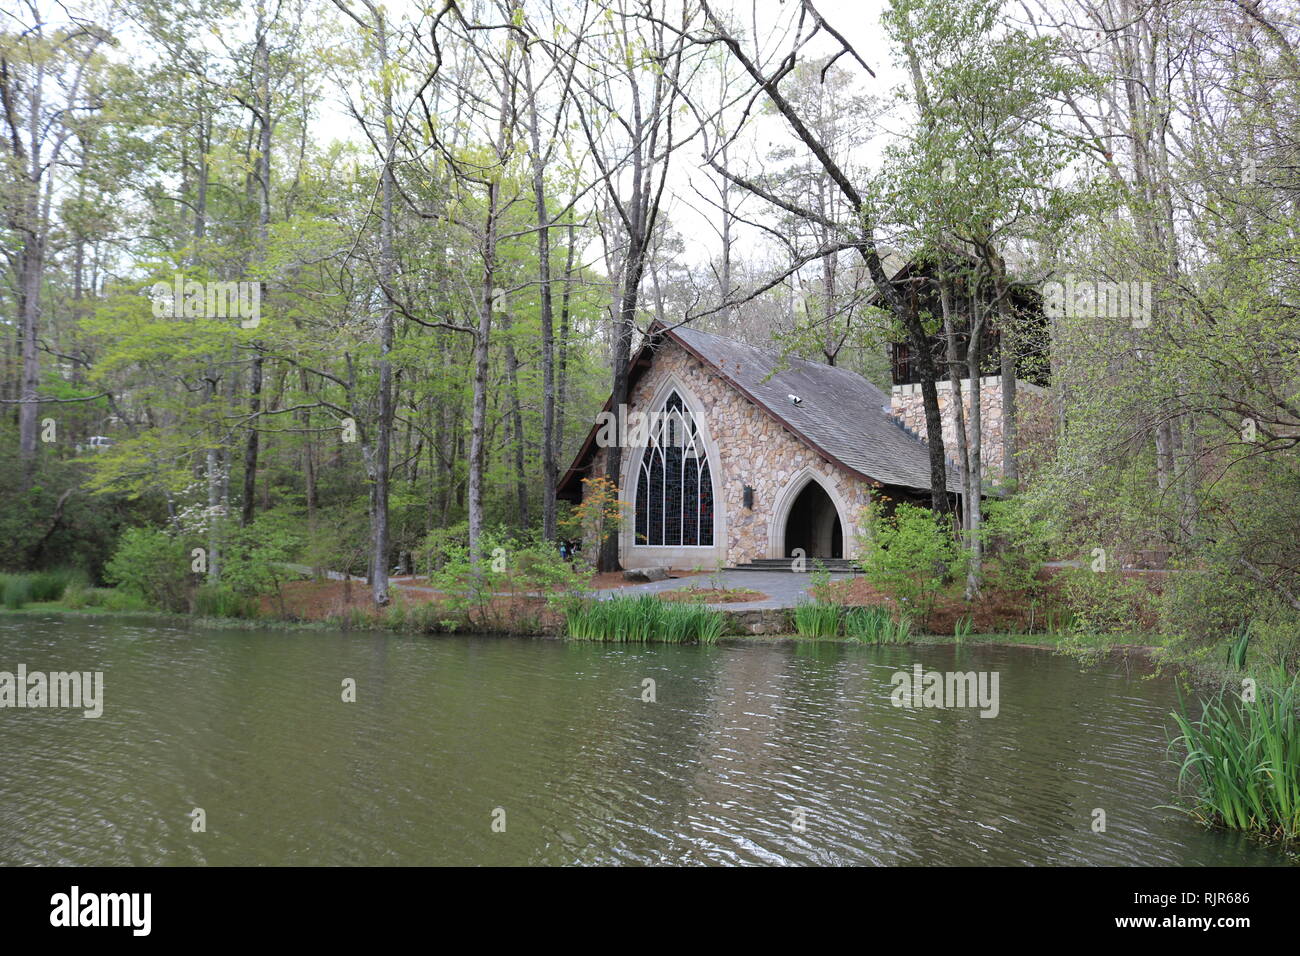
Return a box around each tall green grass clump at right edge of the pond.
[1173,669,1300,840]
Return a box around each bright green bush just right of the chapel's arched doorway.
[861,502,967,622]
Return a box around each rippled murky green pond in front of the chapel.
[0,615,1286,865]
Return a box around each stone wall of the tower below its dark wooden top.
[889,375,1048,479]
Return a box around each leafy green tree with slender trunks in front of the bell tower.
[875,0,1088,600]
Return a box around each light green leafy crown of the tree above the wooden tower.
[871,0,1097,273]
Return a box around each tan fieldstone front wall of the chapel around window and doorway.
[584,342,871,568]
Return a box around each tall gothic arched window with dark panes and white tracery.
[636,392,714,548]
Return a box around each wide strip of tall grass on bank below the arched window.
[564,594,724,644]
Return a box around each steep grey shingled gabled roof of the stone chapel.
[560,324,959,498]
